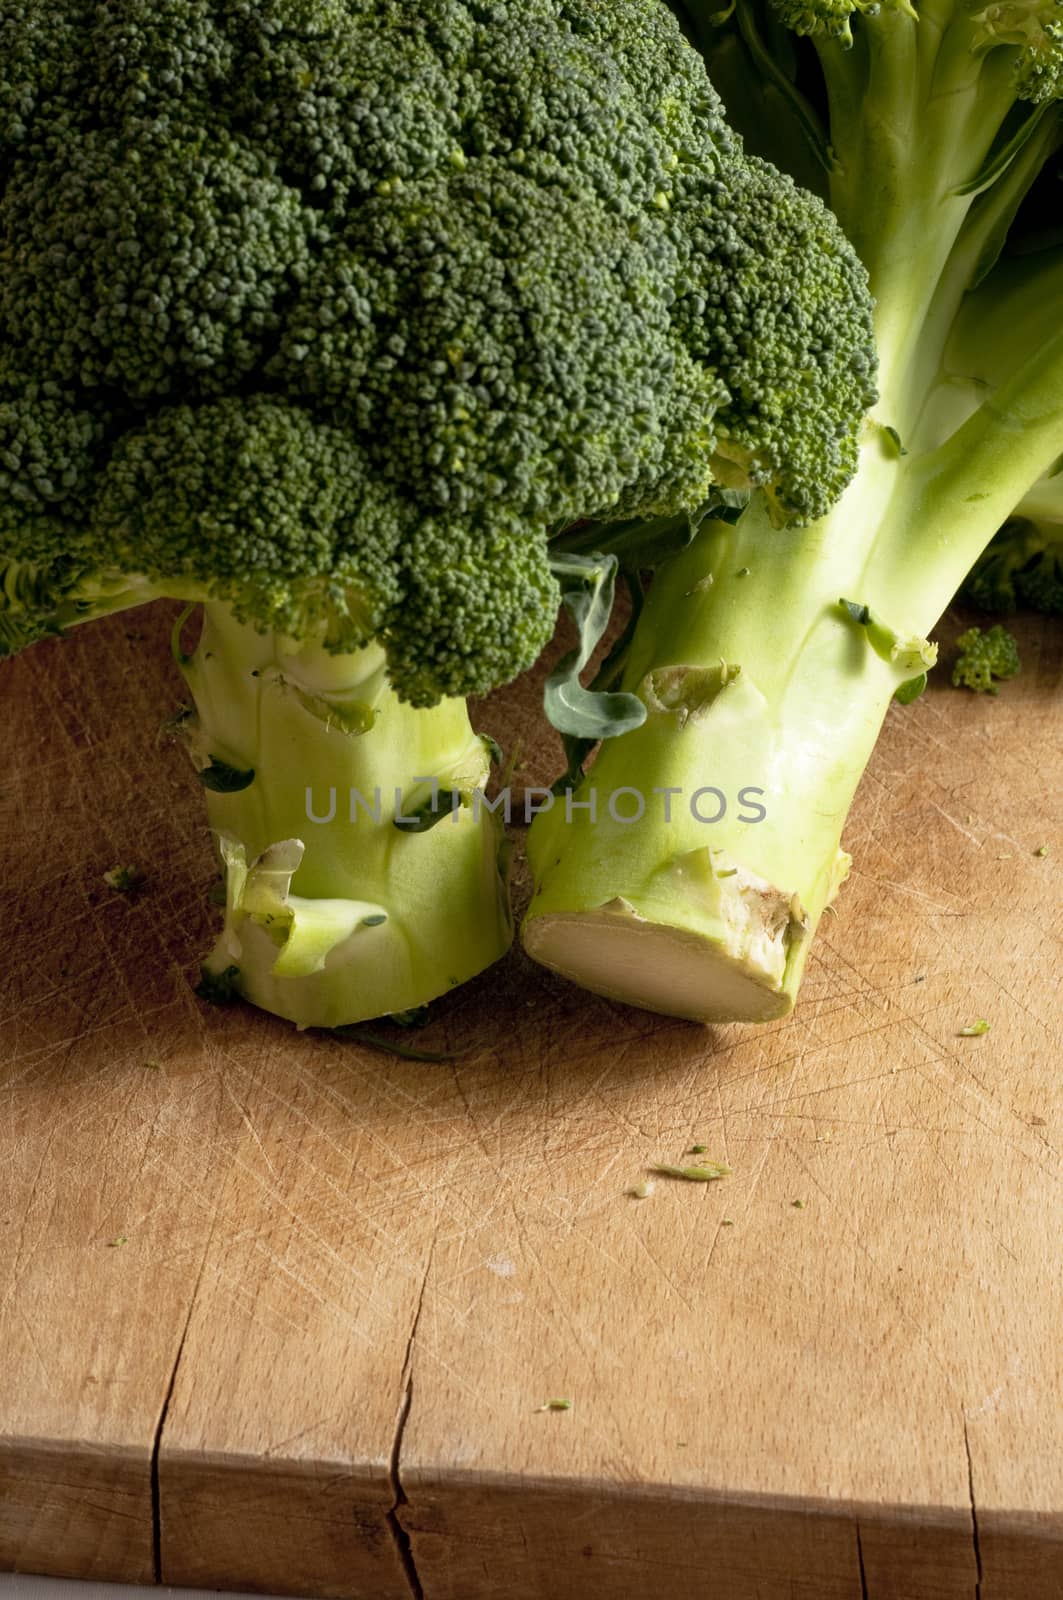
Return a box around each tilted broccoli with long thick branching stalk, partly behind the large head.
[523,0,1063,1021]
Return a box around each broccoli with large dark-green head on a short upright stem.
[0,0,876,1027]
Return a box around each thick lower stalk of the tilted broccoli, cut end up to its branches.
[523,489,903,1021]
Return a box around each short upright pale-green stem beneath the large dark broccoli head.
[183,605,512,1027]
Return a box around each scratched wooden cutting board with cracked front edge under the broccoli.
[0,608,1063,1600]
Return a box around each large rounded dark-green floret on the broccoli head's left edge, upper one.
[0,122,311,403]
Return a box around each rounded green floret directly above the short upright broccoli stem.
[91,395,406,650]
